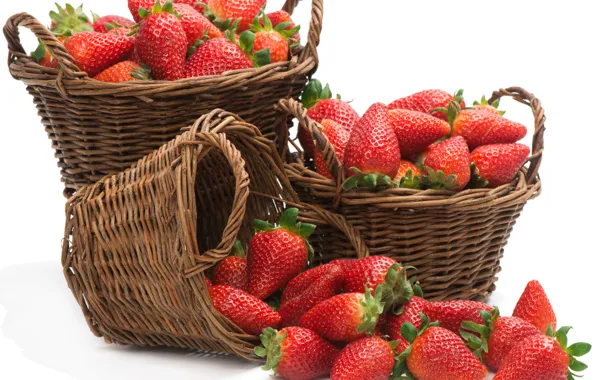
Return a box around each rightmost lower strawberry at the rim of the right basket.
[471,144,530,187]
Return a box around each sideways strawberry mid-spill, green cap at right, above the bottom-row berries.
[300,289,383,342]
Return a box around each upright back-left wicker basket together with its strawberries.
[4,0,323,196]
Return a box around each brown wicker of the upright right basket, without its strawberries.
[278,87,545,300]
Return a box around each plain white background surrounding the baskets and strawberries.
[0,0,596,380]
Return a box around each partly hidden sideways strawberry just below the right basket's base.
[425,300,493,334]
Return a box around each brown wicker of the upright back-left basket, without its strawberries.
[4,0,323,196]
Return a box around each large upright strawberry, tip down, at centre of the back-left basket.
[136,1,188,80]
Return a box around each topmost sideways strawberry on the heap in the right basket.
[388,90,466,120]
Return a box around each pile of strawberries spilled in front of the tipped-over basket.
[206,208,591,380]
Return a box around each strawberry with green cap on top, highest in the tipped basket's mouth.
[248,208,316,299]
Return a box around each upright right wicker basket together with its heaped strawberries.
[278,84,545,300]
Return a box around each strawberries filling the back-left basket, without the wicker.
[31,0,300,82]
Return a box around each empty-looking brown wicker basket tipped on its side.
[62,110,368,358]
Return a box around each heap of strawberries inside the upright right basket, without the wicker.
[298,80,530,191]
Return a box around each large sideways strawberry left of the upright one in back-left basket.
[64,32,134,77]
